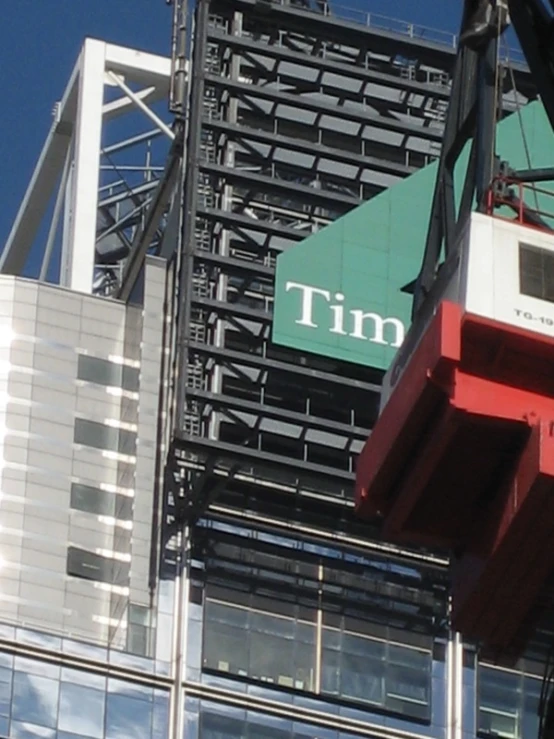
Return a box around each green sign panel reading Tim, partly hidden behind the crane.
[273,103,554,369]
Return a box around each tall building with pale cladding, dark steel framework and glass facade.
[0,0,541,739]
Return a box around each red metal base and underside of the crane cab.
[356,302,554,654]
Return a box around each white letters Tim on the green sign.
[285,281,405,348]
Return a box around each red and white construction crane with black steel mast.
[356,0,554,737]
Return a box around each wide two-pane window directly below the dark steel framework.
[203,594,432,721]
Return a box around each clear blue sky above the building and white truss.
[0,0,462,249]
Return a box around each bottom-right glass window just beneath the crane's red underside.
[477,665,541,739]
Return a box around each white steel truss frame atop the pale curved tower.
[0,39,176,293]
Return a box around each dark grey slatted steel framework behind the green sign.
[166,0,534,652]
